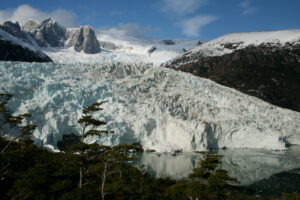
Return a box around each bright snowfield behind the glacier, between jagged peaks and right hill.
[44,35,198,66]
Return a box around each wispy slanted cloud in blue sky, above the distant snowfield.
[178,15,217,37]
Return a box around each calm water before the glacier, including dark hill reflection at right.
[133,146,300,195]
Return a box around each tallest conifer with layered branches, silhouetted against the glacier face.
[69,101,136,200]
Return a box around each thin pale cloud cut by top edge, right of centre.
[161,0,208,15]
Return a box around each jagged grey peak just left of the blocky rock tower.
[28,18,66,47]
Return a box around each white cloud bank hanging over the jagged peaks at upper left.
[0,5,76,27]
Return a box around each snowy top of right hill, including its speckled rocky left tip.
[165,29,300,68]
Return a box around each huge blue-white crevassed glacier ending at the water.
[0,62,300,152]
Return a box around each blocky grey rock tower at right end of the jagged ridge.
[66,26,101,54]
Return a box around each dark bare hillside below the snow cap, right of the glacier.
[165,43,300,112]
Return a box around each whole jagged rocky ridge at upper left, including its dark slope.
[0,19,101,62]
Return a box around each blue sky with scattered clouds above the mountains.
[0,0,300,40]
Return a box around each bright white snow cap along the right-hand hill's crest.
[190,29,300,56]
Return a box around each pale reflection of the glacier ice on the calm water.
[133,146,300,185]
